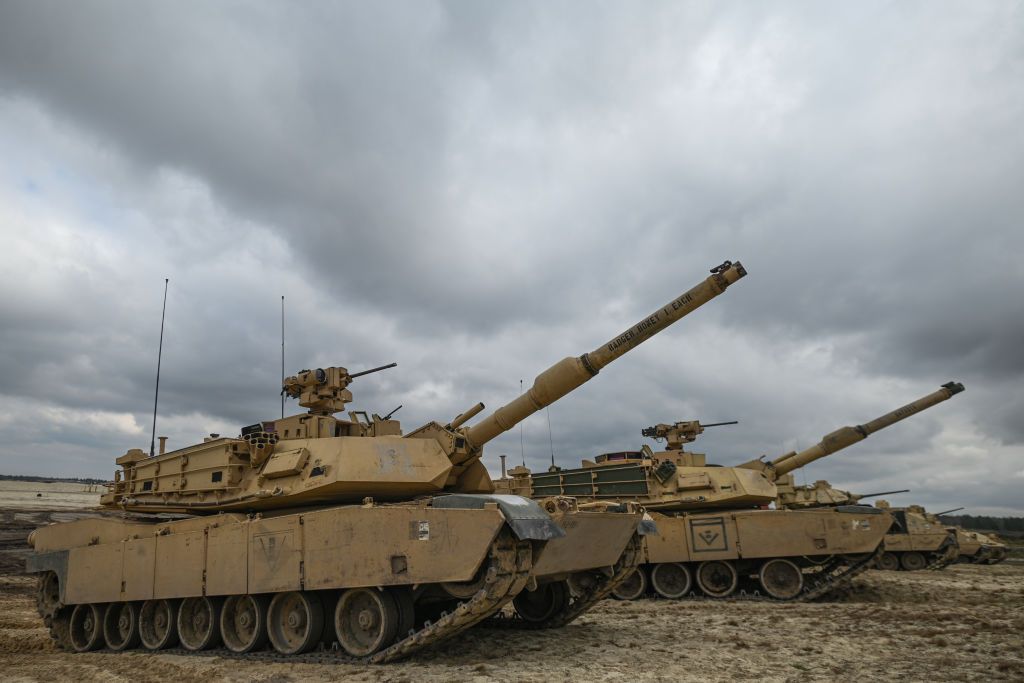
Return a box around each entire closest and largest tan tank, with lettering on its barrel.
[27,262,745,661]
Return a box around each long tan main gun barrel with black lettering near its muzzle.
[466,261,746,447]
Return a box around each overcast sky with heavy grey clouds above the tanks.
[0,0,1024,515]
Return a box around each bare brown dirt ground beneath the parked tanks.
[0,499,1024,683]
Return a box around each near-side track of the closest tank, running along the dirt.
[44,533,532,664]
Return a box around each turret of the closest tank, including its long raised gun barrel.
[101,261,745,513]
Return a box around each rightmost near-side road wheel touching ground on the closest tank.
[334,588,399,657]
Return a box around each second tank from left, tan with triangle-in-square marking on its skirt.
[500,385,963,600]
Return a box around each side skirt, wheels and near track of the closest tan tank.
[28,501,554,663]
